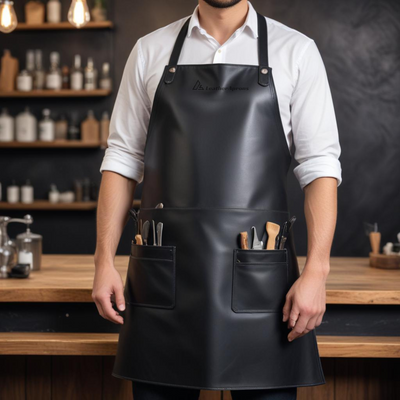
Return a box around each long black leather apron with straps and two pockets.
[113,10,325,390]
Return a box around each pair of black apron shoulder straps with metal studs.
[165,12,270,86]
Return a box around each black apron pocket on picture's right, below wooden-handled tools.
[232,249,289,313]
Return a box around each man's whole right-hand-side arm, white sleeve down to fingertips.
[283,36,342,340]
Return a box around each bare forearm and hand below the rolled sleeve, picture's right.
[283,177,337,341]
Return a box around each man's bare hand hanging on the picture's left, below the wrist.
[92,266,125,324]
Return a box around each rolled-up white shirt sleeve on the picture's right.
[290,39,342,190]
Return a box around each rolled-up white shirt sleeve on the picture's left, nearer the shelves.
[100,39,151,183]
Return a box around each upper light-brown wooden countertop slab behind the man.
[0,255,400,305]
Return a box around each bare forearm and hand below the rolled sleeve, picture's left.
[92,171,137,324]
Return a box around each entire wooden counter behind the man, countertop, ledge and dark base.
[0,255,400,400]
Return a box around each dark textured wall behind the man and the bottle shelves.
[0,0,400,256]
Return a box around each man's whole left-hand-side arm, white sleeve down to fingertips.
[92,39,150,324]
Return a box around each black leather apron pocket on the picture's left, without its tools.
[124,242,176,308]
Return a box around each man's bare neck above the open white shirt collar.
[198,0,249,45]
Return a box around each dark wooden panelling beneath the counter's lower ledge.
[0,356,400,400]
